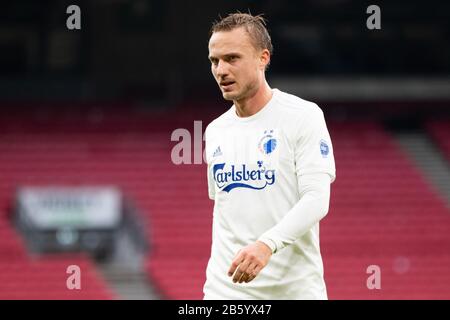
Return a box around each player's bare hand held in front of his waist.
[228,241,272,283]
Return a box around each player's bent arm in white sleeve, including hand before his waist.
[228,106,336,283]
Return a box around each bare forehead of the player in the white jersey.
[208,28,255,57]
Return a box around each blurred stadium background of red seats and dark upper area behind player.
[0,0,450,299]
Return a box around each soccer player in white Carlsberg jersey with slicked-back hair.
[203,13,335,299]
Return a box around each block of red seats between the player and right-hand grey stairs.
[321,123,450,299]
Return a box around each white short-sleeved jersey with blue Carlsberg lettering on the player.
[204,89,335,299]
